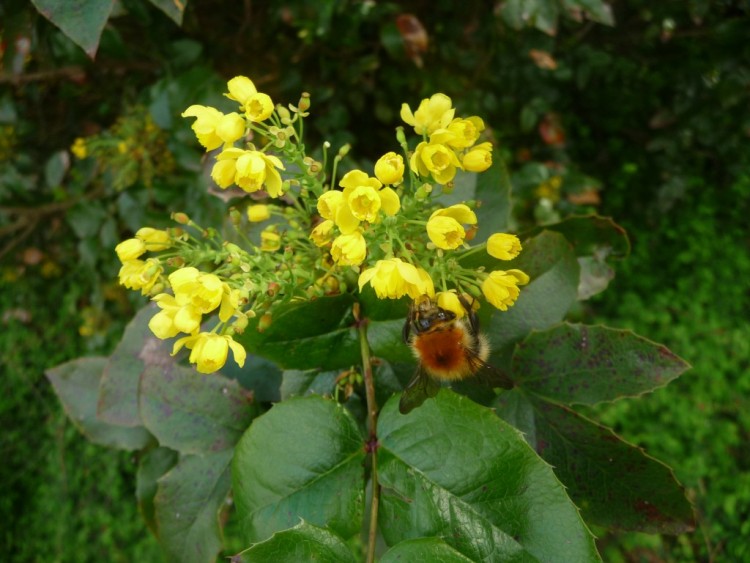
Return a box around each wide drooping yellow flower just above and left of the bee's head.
[359,258,435,299]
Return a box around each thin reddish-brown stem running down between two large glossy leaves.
[357,319,380,563]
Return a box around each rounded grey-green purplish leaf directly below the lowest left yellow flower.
[140,364,259,454]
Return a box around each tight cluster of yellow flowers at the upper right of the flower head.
[401,94,492,184]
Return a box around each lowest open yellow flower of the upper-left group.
[217,148,284,197]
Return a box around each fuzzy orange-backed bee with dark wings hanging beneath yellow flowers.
[399,295,513,414]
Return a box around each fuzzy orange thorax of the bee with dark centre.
[413,326,473,380]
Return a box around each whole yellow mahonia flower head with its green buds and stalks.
[116,76,529,373]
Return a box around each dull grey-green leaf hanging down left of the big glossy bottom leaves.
[154,449,232,563]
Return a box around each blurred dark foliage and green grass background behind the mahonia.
[0,0,750,562]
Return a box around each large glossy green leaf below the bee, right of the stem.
[378,390,599,561]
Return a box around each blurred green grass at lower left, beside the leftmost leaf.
[0,268,162,562]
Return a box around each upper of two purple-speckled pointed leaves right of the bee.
[512,324,690,405]
